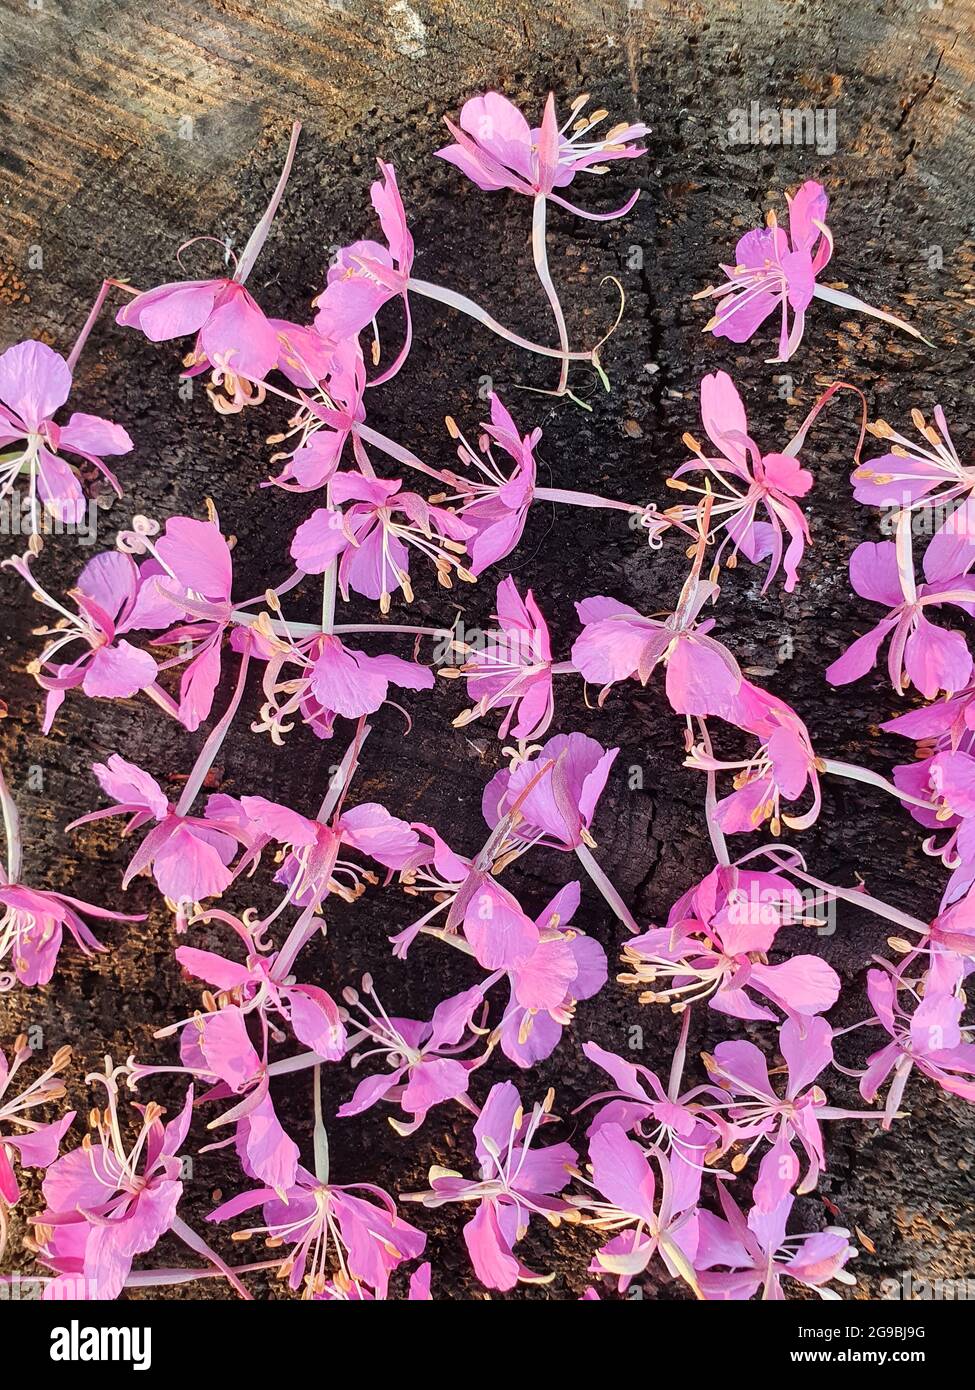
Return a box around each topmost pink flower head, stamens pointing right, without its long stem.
[437,92,648,221]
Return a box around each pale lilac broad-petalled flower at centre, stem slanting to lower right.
[481,734,619,849]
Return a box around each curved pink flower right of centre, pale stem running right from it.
[684,680,823,835]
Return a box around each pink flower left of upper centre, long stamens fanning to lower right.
[291,473,474,613]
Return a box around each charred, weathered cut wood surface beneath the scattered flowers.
[0,0,975,1298]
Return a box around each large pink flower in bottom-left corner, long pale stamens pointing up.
[36,1068,193,1300]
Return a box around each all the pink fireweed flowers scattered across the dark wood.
[0,92,975,1300]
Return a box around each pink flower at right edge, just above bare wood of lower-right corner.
[860,956,975,1129]
